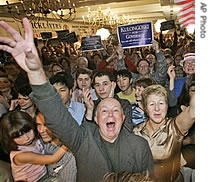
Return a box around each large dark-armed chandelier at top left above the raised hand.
[6,0,76,21]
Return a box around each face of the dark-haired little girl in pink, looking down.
[14,129,35,146]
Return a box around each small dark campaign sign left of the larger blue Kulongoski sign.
[81,35,104,52]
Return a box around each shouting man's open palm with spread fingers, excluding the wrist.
[0,18,41,72]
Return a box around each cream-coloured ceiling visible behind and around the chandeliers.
[0,0,178,22]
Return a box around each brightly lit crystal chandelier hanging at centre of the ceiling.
[82,6,131,28]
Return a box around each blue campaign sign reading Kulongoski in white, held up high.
[117,22,154,48]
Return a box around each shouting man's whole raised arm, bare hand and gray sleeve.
[0,18,82,152]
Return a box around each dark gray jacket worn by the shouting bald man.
[31,82,153,182]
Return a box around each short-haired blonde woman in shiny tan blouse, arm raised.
[133,85,195,182]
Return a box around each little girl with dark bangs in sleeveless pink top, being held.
[0,111,67,182]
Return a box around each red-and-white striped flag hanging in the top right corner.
[174,0,195,28]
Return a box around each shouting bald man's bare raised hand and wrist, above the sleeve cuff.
[0,18,47,85]
